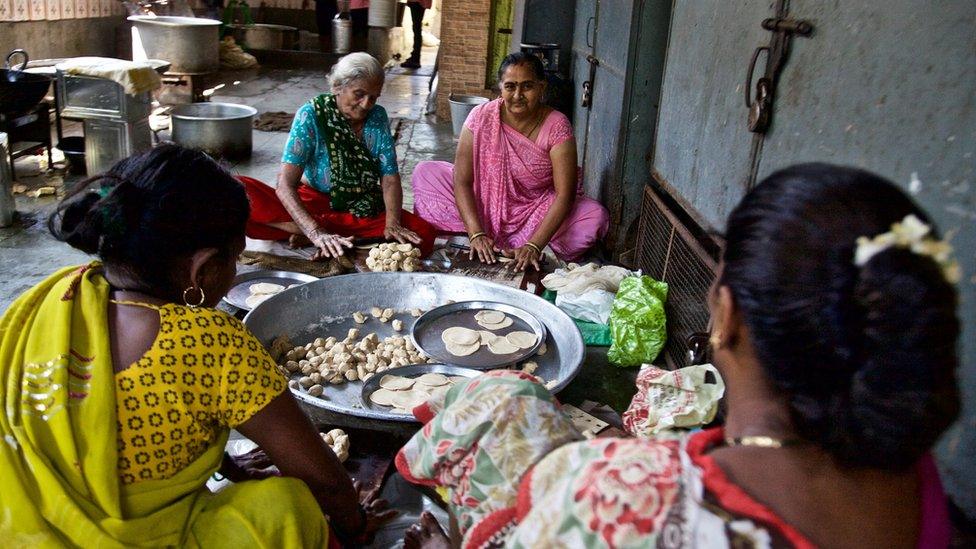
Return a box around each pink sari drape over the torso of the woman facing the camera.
[465,99,582,248]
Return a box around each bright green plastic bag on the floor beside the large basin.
[607,276,668,366]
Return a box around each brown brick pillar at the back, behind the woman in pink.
[437,0,492,120]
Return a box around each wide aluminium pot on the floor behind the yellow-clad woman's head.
[170,103,258,160]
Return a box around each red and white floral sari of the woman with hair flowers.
[396,370,948,548]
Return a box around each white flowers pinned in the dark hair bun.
[854,214,962,284]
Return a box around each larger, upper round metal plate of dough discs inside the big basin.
[410,301,546,370]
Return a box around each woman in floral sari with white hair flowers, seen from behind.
[397,164,960,547]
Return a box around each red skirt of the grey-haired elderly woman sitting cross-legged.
[237,175,437,256]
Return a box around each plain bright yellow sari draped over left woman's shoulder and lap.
[0,263,328,547]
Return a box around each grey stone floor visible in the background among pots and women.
[0,48,455,311]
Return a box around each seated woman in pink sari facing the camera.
[413,53,609,270]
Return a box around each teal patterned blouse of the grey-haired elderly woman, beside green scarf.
[281,102,400,193]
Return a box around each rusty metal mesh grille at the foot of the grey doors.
[637,187,717,368]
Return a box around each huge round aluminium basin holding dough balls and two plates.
[244,272,586,421]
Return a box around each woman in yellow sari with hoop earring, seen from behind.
[0,145,387,547]
